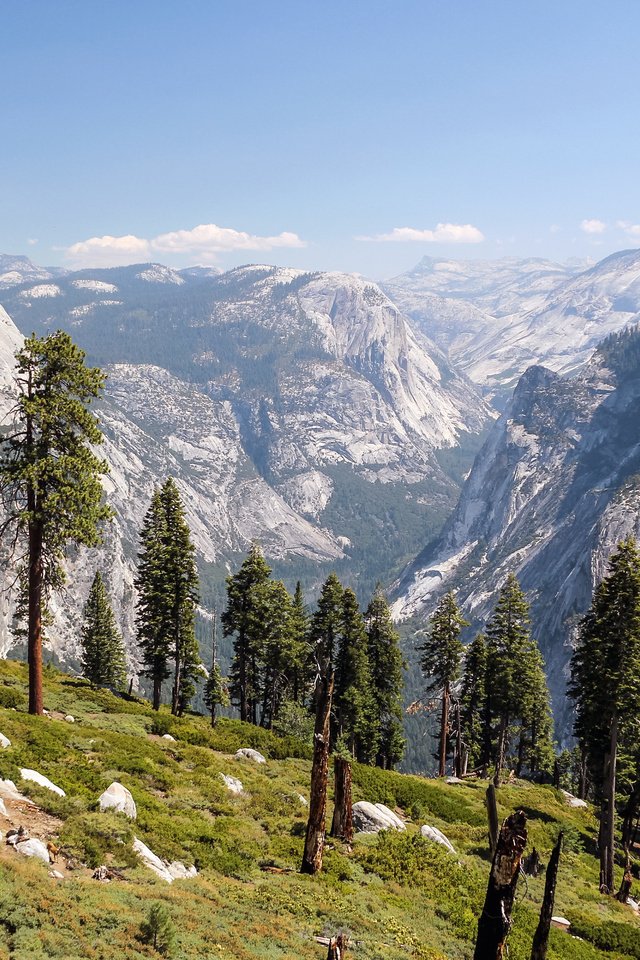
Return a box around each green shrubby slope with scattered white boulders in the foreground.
[0,661,640,960]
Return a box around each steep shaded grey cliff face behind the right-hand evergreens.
[394,334,640,734]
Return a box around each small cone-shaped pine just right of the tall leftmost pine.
[80,573,126,689]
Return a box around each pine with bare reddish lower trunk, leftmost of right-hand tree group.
[418,591,468,777]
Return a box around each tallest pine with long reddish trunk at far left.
[0,331,111,714]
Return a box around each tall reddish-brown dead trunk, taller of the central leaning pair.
[300,673,333,874]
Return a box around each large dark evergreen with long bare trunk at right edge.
[569,537,640,893]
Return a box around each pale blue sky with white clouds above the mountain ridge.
[0,0,640,277]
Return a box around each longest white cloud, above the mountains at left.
[66,223,306,266]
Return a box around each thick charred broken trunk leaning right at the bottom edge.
[473,810,527,960]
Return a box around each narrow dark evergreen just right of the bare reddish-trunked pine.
[460,633,491,773]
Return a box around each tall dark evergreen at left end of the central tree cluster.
[222,543,271,723]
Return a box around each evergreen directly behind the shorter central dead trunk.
[333,588,379,763]
